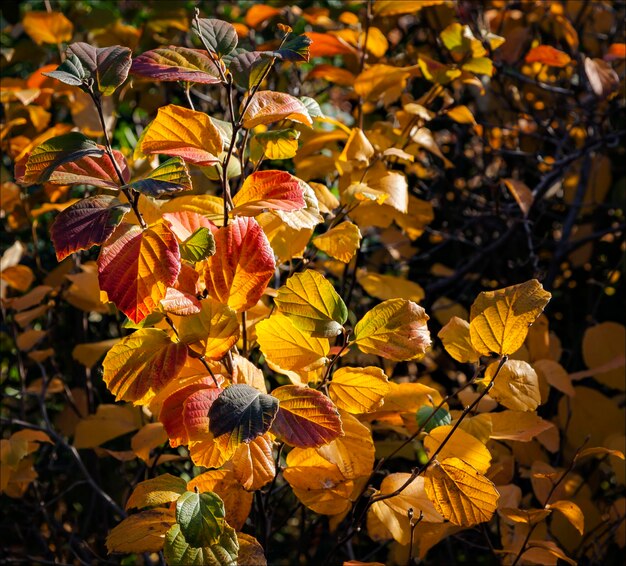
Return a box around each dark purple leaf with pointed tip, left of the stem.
[50,195,131,261]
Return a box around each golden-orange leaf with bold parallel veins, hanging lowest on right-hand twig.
[424,458,500,527]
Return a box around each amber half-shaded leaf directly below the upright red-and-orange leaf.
[177,299,239,360]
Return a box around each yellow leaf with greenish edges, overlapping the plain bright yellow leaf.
[275,269,348,337]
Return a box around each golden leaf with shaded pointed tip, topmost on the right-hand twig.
[470,279,552,356]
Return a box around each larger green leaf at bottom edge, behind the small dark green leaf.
[163,525,239,566]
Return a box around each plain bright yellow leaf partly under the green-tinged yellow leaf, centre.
[256,313,330,373]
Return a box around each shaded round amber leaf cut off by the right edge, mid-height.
[583,322,626,391]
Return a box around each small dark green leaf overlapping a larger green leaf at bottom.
[176,491,226,547]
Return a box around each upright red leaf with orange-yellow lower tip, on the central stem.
[204,217,276,312]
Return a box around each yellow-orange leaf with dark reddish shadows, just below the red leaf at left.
[102,328,187,404]
